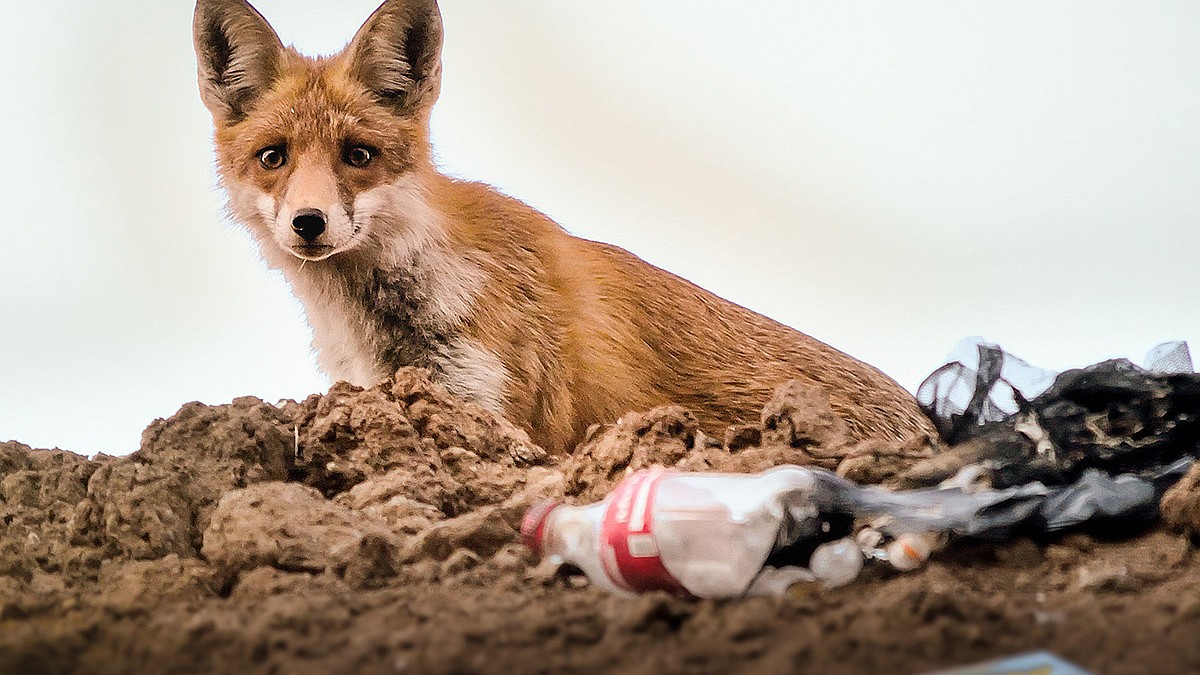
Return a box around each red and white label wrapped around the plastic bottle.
[600,468,691,596]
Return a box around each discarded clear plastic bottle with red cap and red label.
[521,466,844,598]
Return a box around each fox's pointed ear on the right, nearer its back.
[347,0,442,114]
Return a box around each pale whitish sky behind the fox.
[0,0,1200,454]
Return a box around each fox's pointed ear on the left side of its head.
[192,0,283,124]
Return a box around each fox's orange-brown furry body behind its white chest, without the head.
[427,181,931,447]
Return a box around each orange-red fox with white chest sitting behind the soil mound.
[193,0,934,454]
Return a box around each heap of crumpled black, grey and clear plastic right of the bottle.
[883,342,1200,538]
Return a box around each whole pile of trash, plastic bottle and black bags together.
[522,342,1200,598]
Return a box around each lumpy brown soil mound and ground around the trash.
[0,370,1200,675]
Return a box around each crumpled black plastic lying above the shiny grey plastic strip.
[914,346,1200,488]
